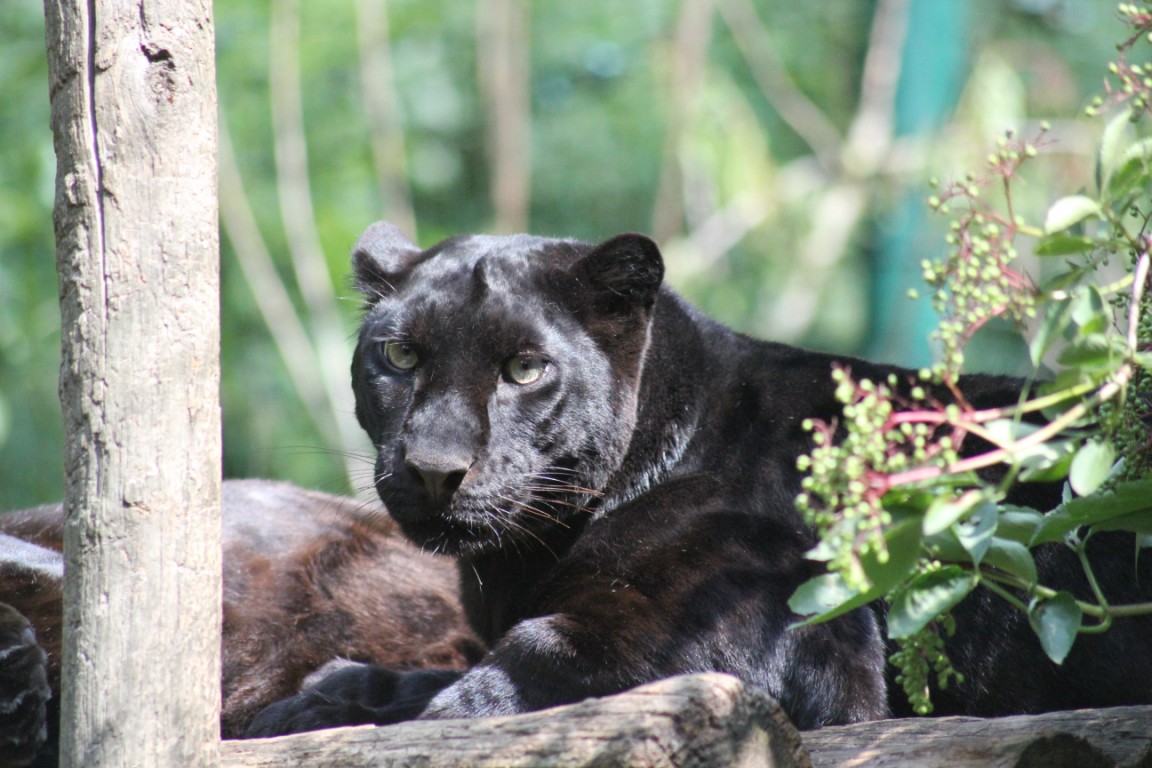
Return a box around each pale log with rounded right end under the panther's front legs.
[221,674,812,768]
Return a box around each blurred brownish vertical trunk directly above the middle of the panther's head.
[476,0,532,233]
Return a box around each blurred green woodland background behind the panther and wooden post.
[0,0,1121,509]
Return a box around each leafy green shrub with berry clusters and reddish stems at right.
[791,3,1152,713]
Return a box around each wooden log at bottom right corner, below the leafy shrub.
[804,706,1152,768]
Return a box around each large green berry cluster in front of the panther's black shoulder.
[796,367,956,590]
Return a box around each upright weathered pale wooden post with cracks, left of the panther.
[45,0,220,768]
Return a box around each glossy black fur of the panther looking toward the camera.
[250,225,1152,736]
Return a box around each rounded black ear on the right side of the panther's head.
[574,233,664,312]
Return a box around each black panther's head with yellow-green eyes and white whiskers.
[353,222,664,554]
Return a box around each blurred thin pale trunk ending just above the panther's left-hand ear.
[356,0,417,242]
